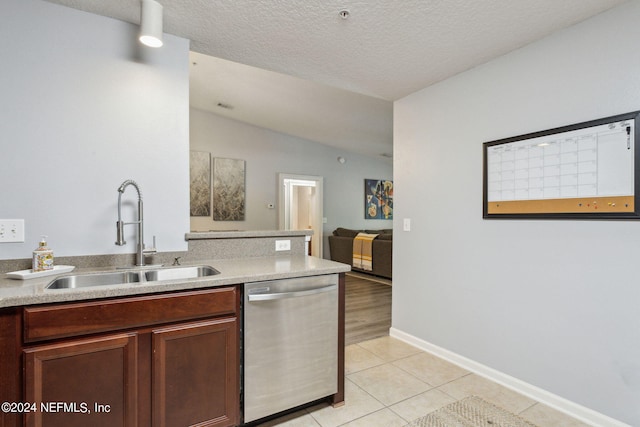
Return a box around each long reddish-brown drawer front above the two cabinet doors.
[23,287,238,343]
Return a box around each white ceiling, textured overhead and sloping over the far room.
[43,0,625,156]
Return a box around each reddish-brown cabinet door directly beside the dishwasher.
[152,317,240,427]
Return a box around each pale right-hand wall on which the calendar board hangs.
[393,1,640,425]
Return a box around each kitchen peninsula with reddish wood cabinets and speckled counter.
[0,231,349,426]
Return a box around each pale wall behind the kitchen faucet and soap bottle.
[0,0,189,259]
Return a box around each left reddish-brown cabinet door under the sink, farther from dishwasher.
[23,333,137,427]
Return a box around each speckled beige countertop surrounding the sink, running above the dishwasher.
[0,255,351,308]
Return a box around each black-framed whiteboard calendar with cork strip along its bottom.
[483,112,640,219]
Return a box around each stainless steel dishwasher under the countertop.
[243,274,338,423]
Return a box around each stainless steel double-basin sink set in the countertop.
[46,265,220,289]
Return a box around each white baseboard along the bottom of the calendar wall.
[389,328,630,427]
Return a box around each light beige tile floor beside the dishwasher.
[260,336,587,427]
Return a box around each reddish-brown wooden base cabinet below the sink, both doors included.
[0,286,240,427]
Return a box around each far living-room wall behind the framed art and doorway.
[190,109,393,258]
